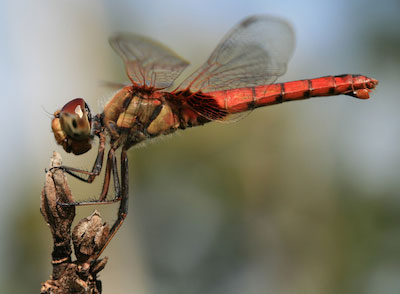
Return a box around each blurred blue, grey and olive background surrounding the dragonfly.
[0,0,400,294]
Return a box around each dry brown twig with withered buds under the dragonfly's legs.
[41,152,109,294]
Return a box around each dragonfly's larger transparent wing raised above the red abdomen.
[177,16,295,93]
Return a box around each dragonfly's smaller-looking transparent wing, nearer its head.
[110,33,189,89]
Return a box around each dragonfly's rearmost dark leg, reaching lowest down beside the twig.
[94,148,129,259]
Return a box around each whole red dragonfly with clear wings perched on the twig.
[52,16,378,256]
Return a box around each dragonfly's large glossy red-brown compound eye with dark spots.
[59,98,91,141]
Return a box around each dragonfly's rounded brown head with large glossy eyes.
[51,98,92,155]
